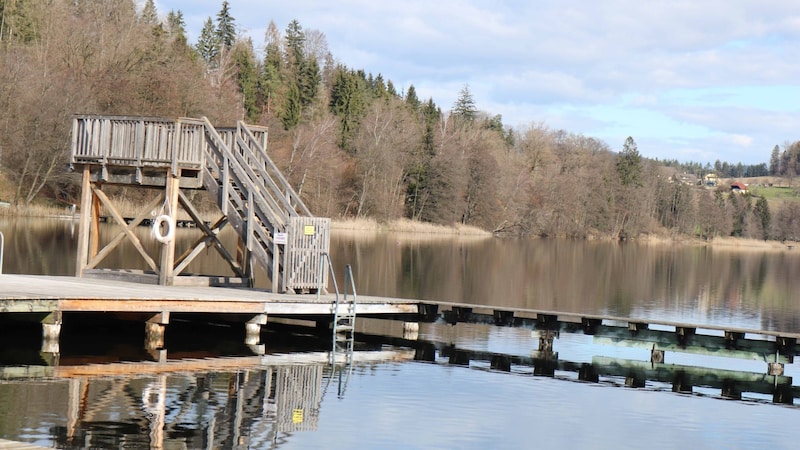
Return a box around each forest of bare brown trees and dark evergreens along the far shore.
[0,0,800,240]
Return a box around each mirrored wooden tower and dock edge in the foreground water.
[0,350,414,448]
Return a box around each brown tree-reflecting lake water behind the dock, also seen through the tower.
[0,218,800,332]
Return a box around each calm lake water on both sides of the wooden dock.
[0,220,800,448]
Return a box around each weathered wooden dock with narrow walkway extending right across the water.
[0,274,800,374]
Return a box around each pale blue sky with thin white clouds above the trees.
[155,0,800,165]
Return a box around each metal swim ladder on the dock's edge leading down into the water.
[317,253,357,397]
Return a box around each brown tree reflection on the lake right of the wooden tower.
[331,234,800,326]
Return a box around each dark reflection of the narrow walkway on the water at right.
[358,318,800,405]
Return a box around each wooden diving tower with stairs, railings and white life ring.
[69,115,330,293]
